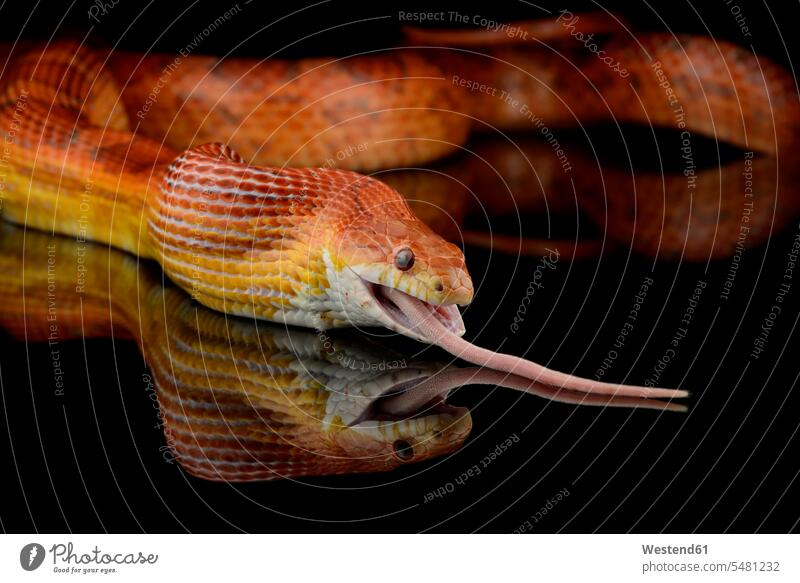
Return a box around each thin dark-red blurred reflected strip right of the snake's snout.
[462,231,609,259]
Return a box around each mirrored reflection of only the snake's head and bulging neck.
[143,276,472,481]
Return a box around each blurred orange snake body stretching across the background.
[114,15,800,171]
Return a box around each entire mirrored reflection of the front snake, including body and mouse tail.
[0,225,680,481]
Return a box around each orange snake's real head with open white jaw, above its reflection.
[326,175,473,341]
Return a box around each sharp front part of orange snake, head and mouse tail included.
[3,28,708,406]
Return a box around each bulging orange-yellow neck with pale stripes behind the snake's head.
[148,144,350,328]
